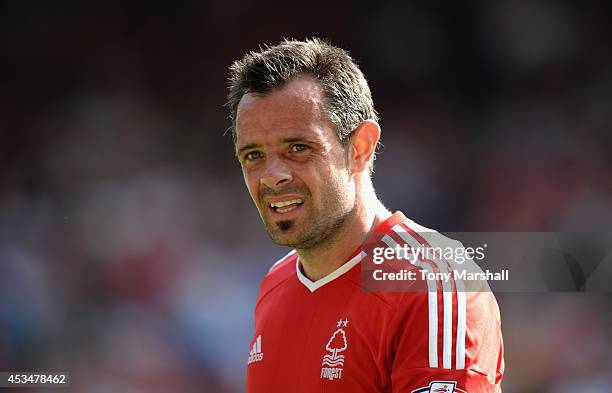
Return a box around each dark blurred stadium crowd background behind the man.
[0,0,612,393]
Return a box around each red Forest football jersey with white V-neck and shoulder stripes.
[247,212,504,393]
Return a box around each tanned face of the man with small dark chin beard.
[236,77,355,248]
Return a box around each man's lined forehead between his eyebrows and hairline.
[236,77,331,145]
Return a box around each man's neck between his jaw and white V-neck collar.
[296,190,391,281]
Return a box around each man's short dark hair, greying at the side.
[227,38,378,149]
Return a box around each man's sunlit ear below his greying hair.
[348,120,380,173]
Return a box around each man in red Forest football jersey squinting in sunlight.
[228,39,503,393]
